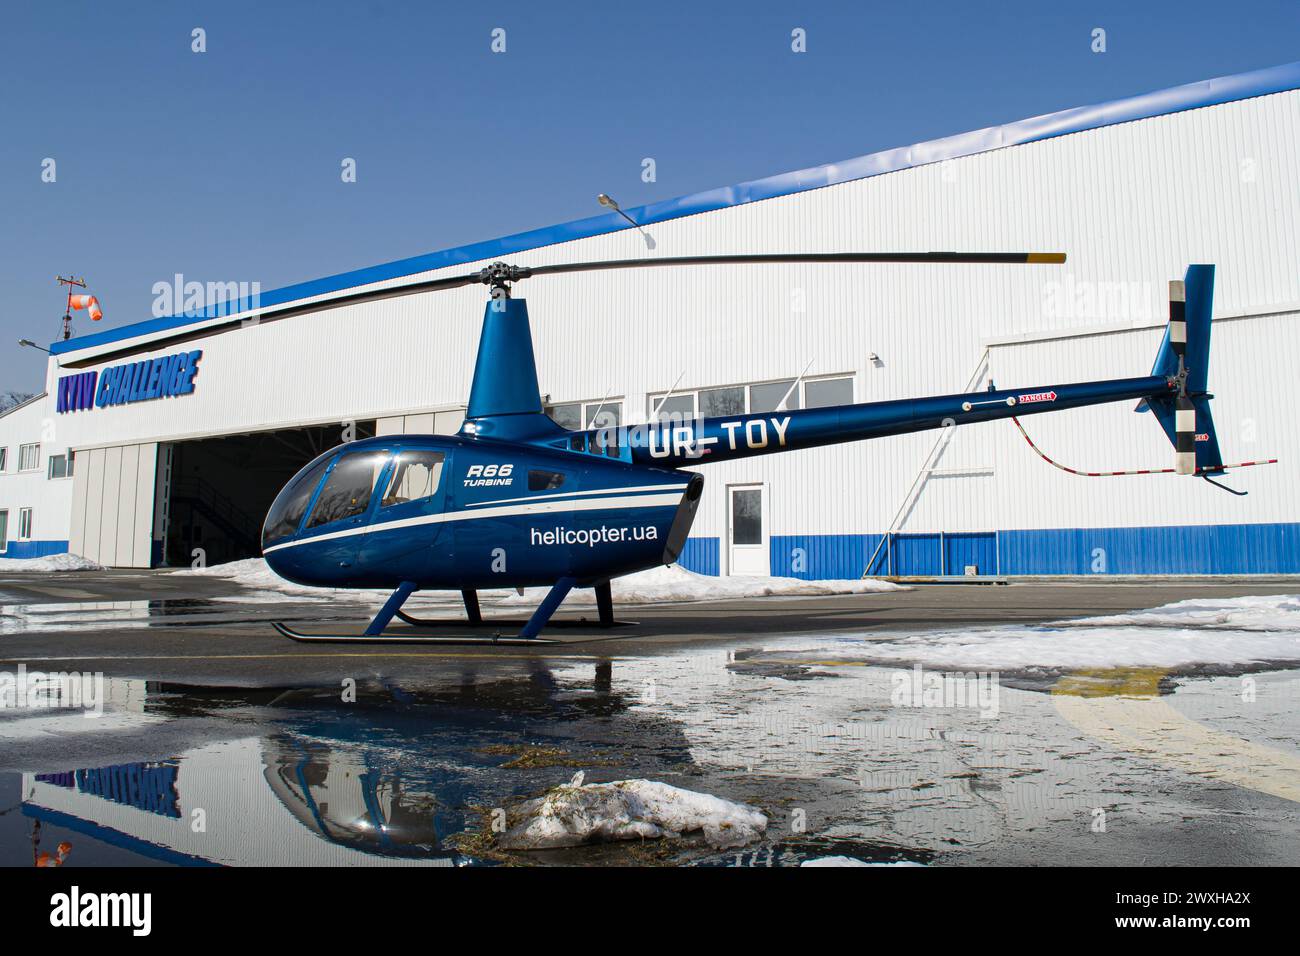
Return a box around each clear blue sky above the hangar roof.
[0,0,1300,392]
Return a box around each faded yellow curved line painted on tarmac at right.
[1052,670,1300,803]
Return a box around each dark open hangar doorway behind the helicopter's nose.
[157,420,374,567]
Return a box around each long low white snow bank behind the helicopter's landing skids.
[174,558,905,606]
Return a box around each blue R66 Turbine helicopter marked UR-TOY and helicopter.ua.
[261,252,1225,644]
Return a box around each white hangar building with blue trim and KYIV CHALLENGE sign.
[0,62,1300,578]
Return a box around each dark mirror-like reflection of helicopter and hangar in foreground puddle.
[12,667,650,865]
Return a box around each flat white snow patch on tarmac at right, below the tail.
[811,594,1300,671]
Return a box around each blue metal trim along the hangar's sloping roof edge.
[49,61,1300,355]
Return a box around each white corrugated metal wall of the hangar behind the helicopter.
[48,92,1300,576]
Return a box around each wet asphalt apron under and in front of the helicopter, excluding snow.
[0,571,1300,866]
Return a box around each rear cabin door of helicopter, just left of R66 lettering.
[361,449,447,564]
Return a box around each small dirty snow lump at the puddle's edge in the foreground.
[497,773,767,849]
